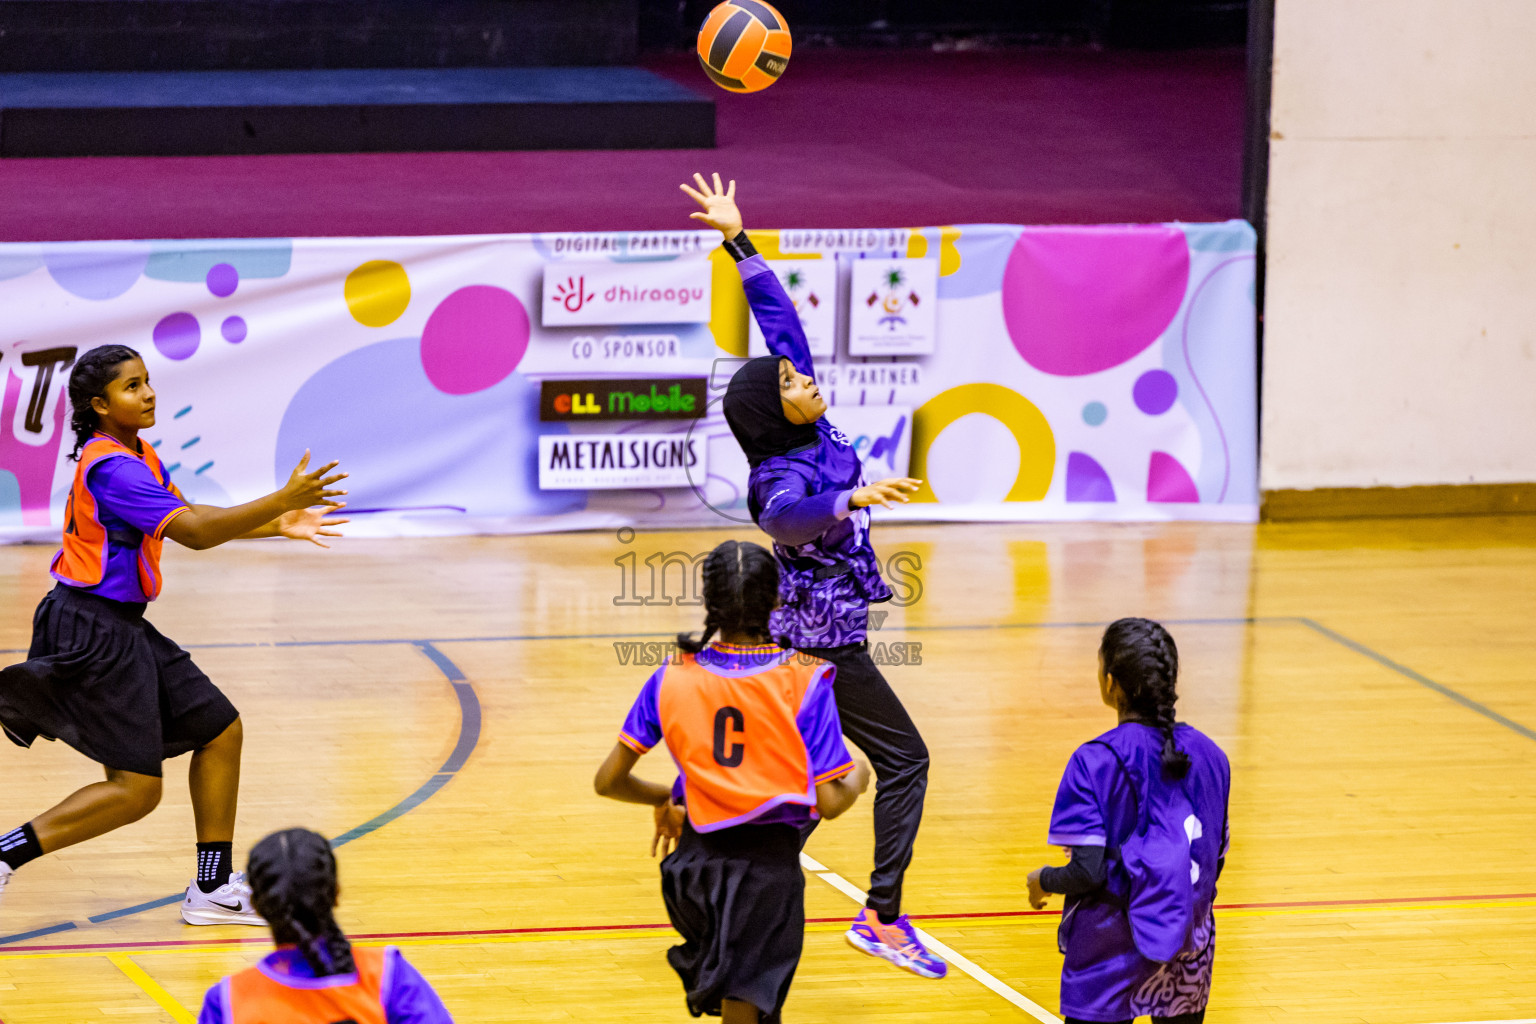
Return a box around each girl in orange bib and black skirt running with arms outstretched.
[0,345,347,926]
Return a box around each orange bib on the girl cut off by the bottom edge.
[229,947,387,1024]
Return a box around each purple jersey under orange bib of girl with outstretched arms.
[54,454,187,603]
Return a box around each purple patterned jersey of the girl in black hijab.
[737,256,891,648]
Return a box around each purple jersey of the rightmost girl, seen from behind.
[1049,722,1230,1021]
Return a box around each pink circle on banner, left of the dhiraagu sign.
[421,284,528,395]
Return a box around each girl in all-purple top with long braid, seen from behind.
[1029,619,1232,1024]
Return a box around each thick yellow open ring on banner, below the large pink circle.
[912,384,1055,502]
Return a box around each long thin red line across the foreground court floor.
[0,892,1536,957]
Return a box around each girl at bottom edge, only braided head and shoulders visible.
[198,829,453,1024]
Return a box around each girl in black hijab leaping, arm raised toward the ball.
[682,175,948,978]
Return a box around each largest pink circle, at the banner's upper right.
[1003,224,1189,376]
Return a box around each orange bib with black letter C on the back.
[657,652,826,832]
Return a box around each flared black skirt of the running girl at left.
[0,583,240,777]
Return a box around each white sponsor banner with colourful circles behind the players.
[0,221,1258,540]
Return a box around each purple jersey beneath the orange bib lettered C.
[619,643,854,827]
